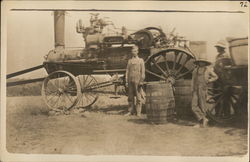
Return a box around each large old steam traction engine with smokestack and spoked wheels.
[7,10,247,121]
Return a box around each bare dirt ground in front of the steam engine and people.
[7,95,248,156]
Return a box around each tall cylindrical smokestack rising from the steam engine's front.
[54,11,65,48]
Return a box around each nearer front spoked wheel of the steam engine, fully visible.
[42,71,80,110]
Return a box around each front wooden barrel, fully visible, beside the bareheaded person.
[146,82,175,124]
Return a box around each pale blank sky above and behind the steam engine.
[5,1,249,78]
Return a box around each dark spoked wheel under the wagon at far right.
[207,81,242,123]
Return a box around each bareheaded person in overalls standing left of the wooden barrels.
[125,45,145,116]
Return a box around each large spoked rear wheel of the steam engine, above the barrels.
[146,49,195,84]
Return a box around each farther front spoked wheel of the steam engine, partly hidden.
[76,75,98,108]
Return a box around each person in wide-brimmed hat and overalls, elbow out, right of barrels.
[191,59,218,127]
